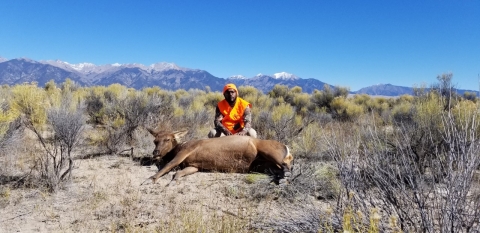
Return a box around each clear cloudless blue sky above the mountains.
[0,0,480,91]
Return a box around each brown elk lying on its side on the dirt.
[149,129,293,183]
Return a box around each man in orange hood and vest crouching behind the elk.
[208,83,257,138]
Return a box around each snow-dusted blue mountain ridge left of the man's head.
[0,58,229,90]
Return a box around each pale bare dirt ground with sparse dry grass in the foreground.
[0,156,327,232]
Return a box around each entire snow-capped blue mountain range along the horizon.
[0,57,478,96]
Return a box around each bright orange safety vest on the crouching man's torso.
[218,97,252,134]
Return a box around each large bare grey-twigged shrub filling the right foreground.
[323,98,480,232]
